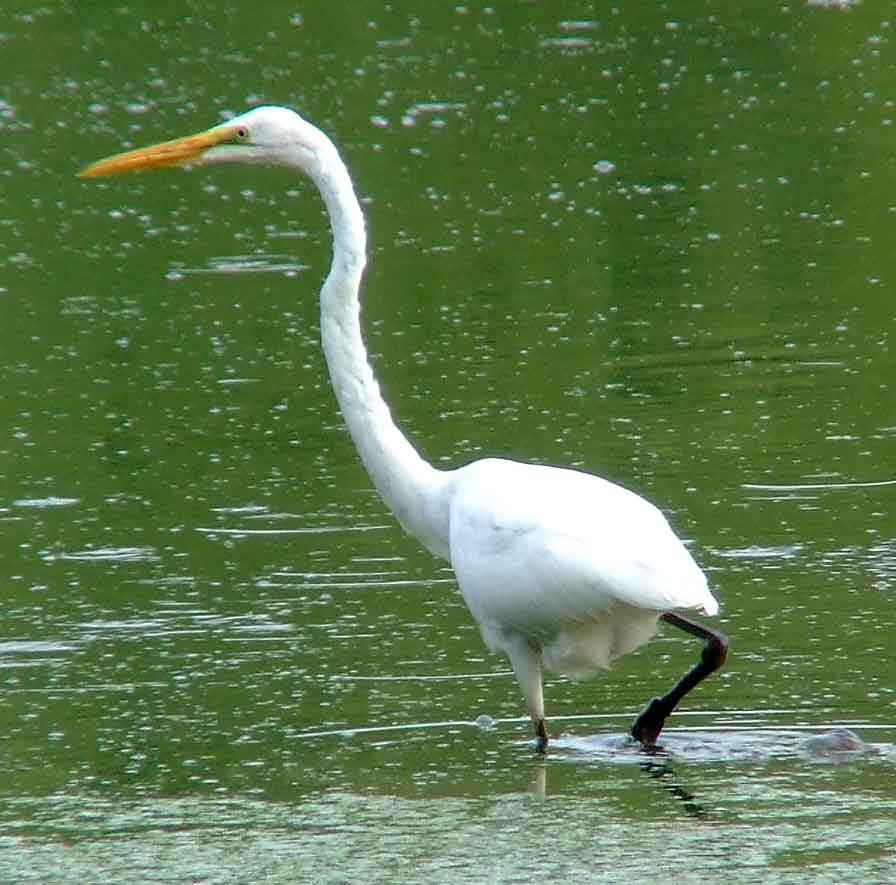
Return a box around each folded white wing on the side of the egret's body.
[451,460,718,633]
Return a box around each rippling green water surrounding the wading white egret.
[0,0,896,882]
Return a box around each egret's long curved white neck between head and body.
[312,140,450,558]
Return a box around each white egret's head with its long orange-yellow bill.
[78,106,330,178]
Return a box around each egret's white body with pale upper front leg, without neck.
[449,459,718,720]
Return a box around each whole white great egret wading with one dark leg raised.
[80,107,728,753]
